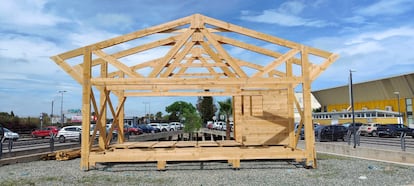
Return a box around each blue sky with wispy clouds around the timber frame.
[0,0,414,116]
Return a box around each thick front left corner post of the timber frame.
[80,47,92,170]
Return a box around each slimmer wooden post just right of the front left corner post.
[99,61,109,150]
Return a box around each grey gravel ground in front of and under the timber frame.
[0,154,414,186]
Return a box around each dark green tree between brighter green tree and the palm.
[197,96,217,123]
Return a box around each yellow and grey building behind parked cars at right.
[312,73,414,126]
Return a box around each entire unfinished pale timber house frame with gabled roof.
[51,14,338,170]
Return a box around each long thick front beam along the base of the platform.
[89,146,306,165]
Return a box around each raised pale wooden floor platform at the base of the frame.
[89,140,306,170]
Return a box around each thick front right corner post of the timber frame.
[302,46,316,168]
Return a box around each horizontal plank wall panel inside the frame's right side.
[233,90,293,145]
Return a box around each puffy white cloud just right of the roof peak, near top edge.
[241,1,330,27]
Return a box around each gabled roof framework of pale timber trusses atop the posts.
[52,14,338,97]
